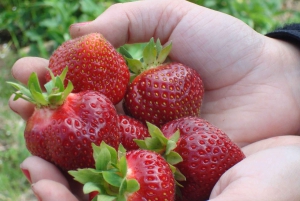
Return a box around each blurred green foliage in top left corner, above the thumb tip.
[0,0,137,58]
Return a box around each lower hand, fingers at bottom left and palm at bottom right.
[21,136,300,201]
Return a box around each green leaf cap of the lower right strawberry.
[134,122,186,186]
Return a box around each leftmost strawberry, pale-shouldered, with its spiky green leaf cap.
[7,68,119,171]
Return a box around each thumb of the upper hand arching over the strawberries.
[70,0,191,47]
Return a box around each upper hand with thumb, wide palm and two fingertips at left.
[10,0,300,200]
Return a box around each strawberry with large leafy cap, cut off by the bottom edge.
[69,142,176,201]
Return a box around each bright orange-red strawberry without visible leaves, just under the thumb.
[46,33,130,104]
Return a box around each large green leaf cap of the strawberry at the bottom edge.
[68,141,140,201]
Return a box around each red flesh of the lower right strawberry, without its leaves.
[161,117,245,201]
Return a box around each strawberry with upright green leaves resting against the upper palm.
[122,39,204,126]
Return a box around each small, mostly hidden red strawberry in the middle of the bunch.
[119,115,150,151]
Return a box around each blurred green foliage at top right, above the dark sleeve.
[190,0,300,34]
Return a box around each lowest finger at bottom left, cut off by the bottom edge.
[31,180,78,201]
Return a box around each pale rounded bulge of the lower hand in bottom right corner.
[210,145,300,201]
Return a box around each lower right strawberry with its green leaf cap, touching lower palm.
[136,117,245,201]
